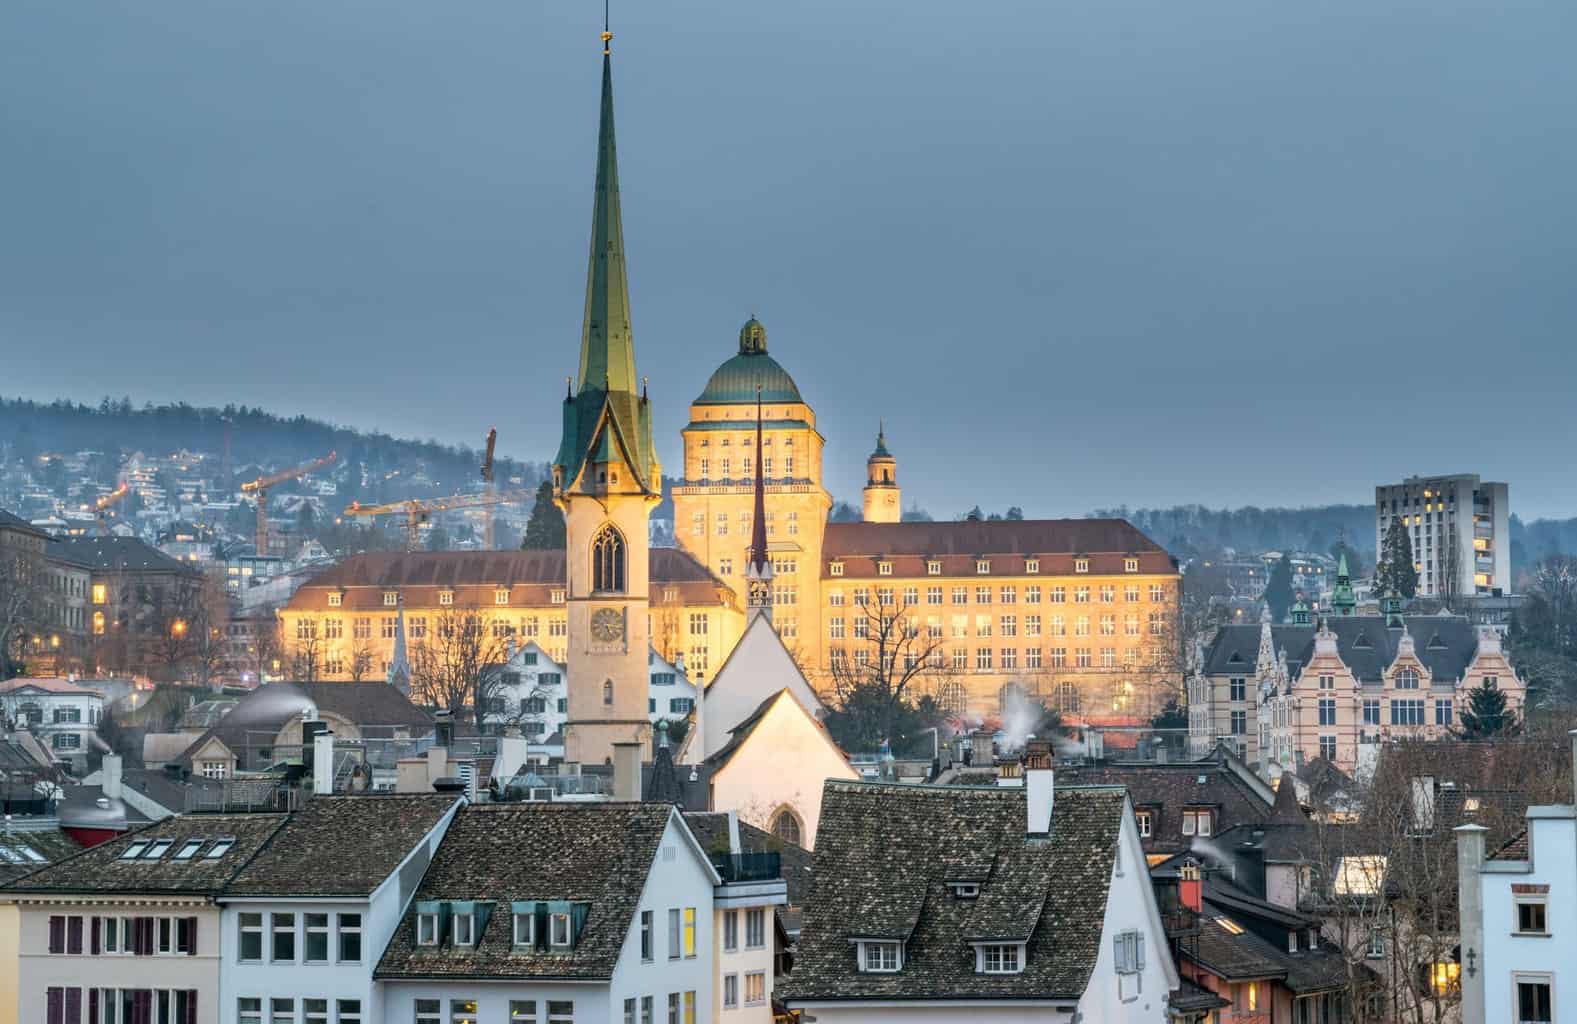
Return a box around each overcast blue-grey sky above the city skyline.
[0,0,1577,516]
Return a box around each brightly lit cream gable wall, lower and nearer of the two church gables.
[706,683,859,849]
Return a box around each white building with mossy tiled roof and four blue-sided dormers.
[375,803,722,1024]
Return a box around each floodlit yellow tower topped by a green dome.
[671,317,833,662]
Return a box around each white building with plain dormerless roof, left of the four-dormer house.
[203,794,460,1024]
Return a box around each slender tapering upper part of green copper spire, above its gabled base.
[579,42,636,393]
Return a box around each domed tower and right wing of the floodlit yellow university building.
[673,317,1181,716]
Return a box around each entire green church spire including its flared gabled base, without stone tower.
[554,42,661,494]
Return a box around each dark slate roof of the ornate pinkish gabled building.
[1205,615,1478,683]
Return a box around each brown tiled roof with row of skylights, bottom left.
[5,814,287,893]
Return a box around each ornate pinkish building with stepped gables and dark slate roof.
[1189,612,1527,775]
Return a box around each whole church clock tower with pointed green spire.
[554,32,662,764]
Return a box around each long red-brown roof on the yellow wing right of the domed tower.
[822,519,1176,577]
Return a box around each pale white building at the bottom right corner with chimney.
[1456,729,1577,1024]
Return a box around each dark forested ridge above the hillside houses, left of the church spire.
[0,398,544,491]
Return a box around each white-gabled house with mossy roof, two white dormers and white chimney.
[779,779,1178,1024]
